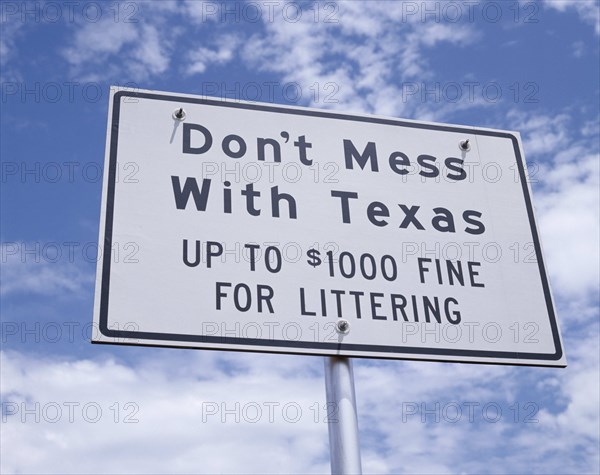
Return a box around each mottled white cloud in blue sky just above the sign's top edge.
[243,2,478,116]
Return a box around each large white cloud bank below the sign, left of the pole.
[1,350,328,474]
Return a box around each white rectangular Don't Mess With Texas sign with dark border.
[93,88,566,367]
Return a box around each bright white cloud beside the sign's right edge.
[508,111,600,299]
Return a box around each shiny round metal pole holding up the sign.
[325,356,362,475]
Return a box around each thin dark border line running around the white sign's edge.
[93,91,563,366]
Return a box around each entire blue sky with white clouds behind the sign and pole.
[0,0,600,474]
